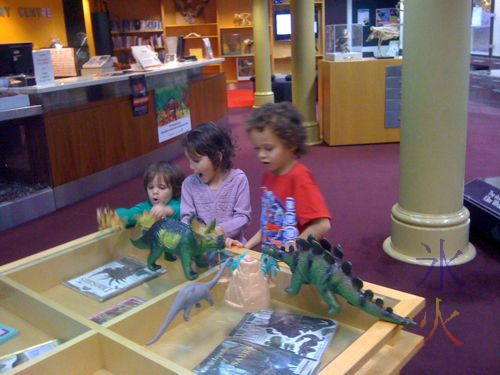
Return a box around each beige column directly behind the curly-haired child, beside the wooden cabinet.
[290,0,321,145]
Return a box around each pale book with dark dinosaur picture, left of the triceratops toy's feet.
[64,257,166,302]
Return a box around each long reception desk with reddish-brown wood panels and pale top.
[2,58,227,229]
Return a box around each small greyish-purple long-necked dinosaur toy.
[146,258,232,345]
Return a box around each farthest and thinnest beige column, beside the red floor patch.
[254,0,274,107]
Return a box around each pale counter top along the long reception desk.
[3,58,224,94]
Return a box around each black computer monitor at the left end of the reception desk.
[0,42,34,77]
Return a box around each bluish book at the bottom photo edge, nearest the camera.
[193,338,319,375]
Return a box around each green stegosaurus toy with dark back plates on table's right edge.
[262,236,416,327]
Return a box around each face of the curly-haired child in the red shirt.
[250,128,297,175]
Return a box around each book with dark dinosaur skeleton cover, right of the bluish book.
[230,310,337,361]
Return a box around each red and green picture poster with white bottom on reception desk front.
[155,83,191,143]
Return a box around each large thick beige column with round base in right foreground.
[384,0,476,267]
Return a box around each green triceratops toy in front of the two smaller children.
[131,216,224,280]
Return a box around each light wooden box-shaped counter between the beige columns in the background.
[318,58,403,146]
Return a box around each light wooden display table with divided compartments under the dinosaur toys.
[0,229,425,375]
